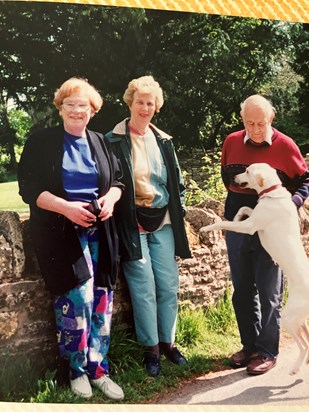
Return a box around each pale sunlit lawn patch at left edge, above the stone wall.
[0,181,29,213]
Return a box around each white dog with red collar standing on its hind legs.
[204,163,309,374]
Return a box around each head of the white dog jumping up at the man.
[235,163,281,193]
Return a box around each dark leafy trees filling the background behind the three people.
[0,2,308,175]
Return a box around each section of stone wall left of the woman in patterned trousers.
[0,212,55,366]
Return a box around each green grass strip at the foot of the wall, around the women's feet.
[0,292,239,404]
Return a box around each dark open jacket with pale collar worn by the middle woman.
[105,119,191,261]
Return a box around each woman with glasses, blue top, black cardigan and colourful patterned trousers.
[18,78,124,400]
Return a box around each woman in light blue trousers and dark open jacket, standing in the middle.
[106,76,191,376]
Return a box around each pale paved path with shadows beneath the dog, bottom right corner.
[156,339,309,405]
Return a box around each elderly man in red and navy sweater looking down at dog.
[222,95,309,375]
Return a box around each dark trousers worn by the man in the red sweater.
[226,231,283,358]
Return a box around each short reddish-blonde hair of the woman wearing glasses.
[54,77,103,113]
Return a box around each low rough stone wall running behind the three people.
[0,208,228,370]
